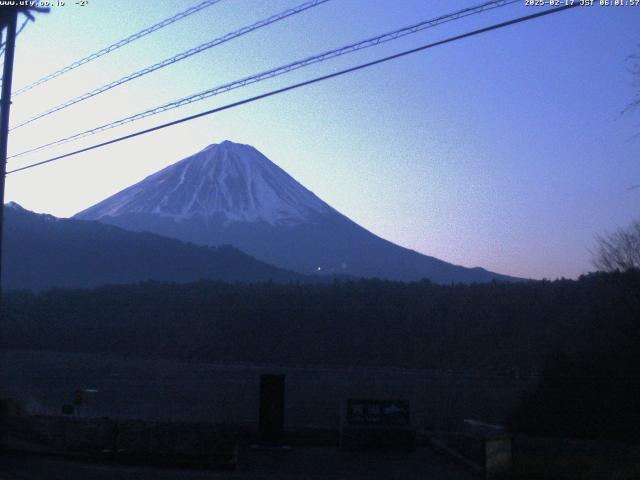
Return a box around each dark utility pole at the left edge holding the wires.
[0,10,18,304]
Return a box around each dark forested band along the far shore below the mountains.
[2,272,640,371]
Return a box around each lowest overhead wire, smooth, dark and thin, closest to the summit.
[7,2,580,174]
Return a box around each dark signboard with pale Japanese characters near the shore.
[346,399,411,427]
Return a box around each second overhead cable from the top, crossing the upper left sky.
[11,0,329,130]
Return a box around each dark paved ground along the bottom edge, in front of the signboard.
[0,448,476,480]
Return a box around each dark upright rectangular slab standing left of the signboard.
[260,375,284,446]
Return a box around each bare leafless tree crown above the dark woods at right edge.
[592,220,640,272]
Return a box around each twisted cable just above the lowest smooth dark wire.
[9,0,520,158]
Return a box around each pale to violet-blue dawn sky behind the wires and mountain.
[5,0,640,279]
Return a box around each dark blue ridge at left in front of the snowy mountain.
[3,203,305,290]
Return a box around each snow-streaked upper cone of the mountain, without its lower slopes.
[77,141,331,225]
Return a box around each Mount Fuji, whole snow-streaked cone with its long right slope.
[74,141,516,283]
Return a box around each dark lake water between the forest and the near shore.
[0,351,536,429]
